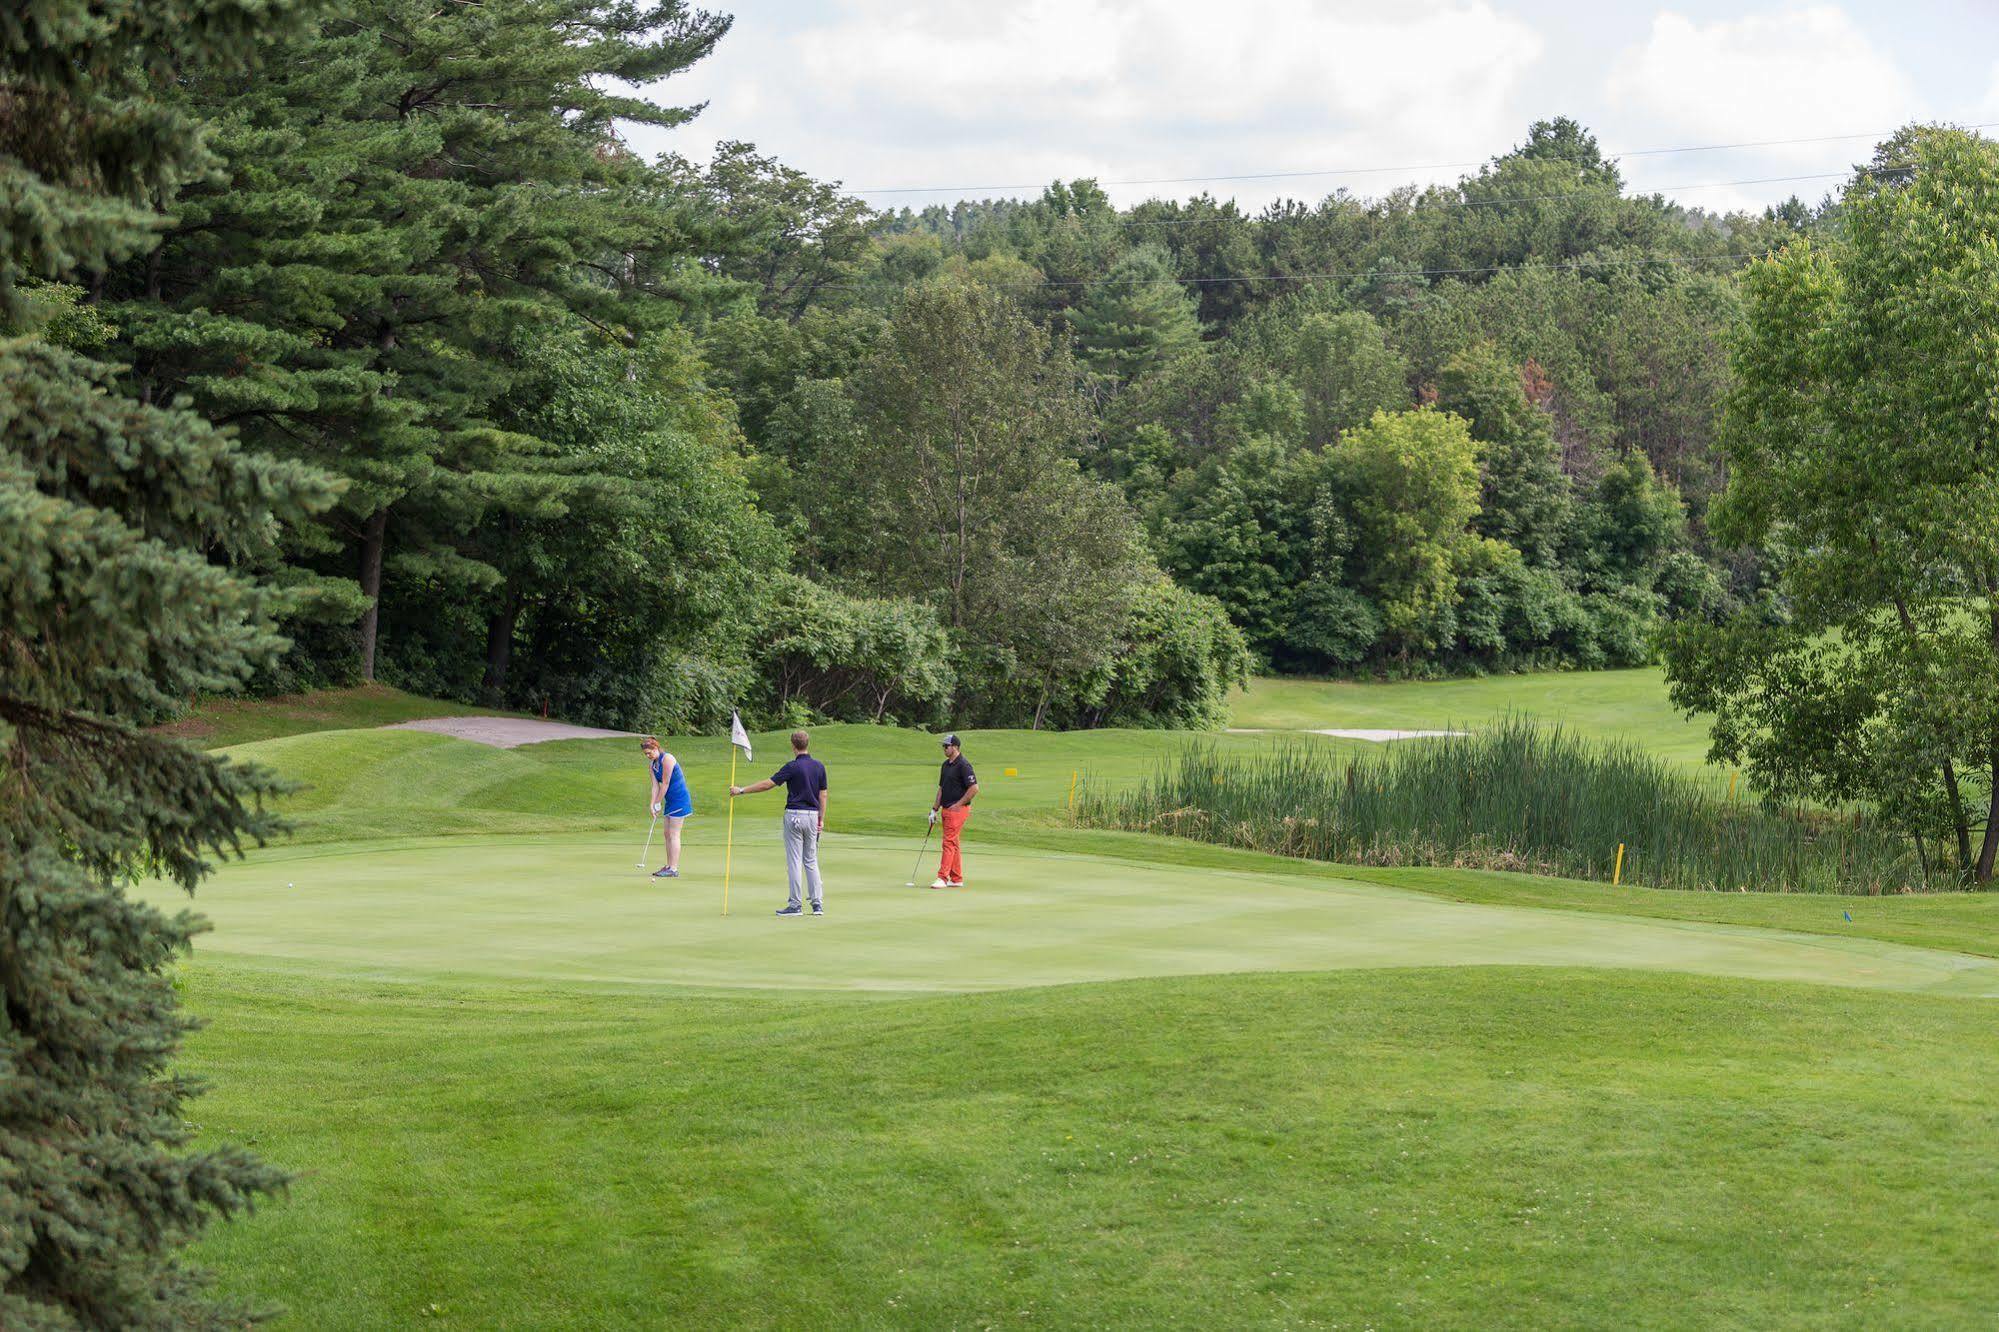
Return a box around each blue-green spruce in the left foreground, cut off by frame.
[0,0,332,1328]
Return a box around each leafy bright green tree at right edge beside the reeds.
[1667,130,1999,884]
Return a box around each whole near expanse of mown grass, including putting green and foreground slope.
[120,680,1999,1330]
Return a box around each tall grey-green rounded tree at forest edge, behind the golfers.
[808,280,1145,724]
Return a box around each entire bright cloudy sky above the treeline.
[628,0,1999,210]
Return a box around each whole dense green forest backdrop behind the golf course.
[7,0,1919,730]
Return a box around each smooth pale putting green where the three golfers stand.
[148,832,1999,996]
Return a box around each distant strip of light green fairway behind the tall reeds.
[1231,668,1707,768]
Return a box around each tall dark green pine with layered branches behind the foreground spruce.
[114,0,728,678]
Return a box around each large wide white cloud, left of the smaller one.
[639,0,1543,204]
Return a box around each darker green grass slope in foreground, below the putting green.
[188,968,1999,1328]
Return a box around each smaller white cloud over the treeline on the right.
[1605,4,1927,208]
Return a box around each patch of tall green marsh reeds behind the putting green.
[1075,716,1943,894]
